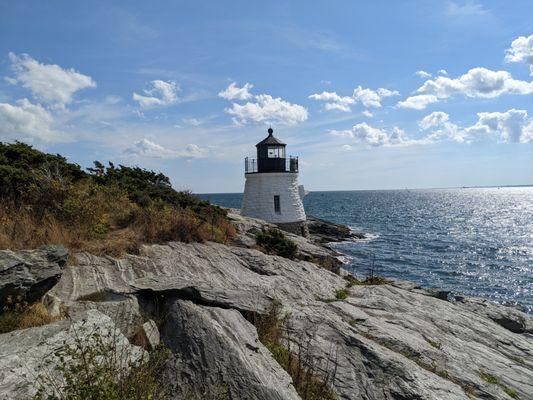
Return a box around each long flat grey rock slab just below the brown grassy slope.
[50,243,346,311]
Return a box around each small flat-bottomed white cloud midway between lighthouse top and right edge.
[330,122,408,148]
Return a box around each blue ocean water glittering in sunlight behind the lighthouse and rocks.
[197,187,533,313]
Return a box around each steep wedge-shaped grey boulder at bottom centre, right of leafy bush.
[162,300,300,400]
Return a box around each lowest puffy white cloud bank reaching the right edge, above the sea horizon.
[419,109,533,143]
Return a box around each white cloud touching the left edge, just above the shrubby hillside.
[0,99,59,141]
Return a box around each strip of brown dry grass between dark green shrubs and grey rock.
[0,199,236,257]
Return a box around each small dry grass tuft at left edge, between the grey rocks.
[0,302,59,333]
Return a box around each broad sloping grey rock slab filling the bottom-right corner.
[284,285,533,400]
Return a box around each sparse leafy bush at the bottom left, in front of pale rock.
[33,327,170,400]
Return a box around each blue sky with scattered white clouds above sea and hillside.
[0,0,533,193]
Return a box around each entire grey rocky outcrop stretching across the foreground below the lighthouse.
[0,212,533,400]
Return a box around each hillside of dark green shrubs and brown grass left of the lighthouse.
[0,142,235,256]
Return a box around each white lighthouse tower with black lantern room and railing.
[241,128,308,236]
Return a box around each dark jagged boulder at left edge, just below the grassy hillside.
[0,246,68,310]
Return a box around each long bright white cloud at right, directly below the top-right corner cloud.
[417,67,533,99]
